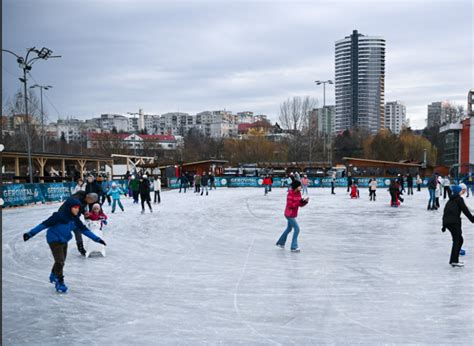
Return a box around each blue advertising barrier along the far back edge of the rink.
[168,177,428,189]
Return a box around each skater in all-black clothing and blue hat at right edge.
[442,185,474,267]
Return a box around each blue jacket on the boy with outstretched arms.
[28,198,100,243]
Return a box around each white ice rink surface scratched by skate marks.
[2,188,474,345]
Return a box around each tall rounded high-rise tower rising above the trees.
[335,30,385,133]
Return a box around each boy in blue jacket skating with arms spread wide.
[23,198,106,293]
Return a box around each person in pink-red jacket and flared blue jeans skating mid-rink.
[276,181,309,252]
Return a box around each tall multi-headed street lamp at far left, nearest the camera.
[2,47,61,183]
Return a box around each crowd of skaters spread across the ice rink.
[23,168,474,293]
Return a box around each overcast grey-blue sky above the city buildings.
[2,0,473,128]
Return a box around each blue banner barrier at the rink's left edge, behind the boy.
[1,180,127,207]
